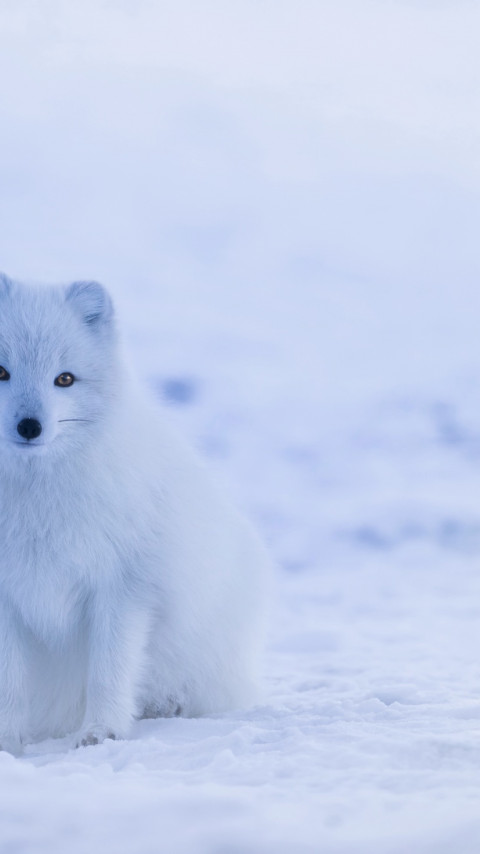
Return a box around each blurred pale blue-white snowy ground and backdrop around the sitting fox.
[0,0,480,854]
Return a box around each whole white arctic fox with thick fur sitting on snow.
[0,275,268,753]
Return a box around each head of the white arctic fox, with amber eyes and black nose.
[0,274,118,459]
